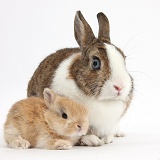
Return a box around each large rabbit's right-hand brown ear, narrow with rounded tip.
[97,12,110,42]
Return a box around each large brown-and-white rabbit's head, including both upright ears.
[70,11,133,101]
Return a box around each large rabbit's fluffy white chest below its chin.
[88,100,125,137]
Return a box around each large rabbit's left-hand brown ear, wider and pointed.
[74,11,95,48]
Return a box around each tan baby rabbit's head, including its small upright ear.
[43,88,89,137]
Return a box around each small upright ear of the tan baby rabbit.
[43,88,58,108]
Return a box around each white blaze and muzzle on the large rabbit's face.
[98,44,132,101]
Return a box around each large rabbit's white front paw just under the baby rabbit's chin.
[81,134,103,146]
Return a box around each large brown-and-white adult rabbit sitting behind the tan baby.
[28,11,133,146]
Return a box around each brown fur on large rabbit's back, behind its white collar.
[27,48,80,97]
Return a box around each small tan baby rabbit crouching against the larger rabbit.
[4,88,89,149]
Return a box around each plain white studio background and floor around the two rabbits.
[0,0,160,160]
